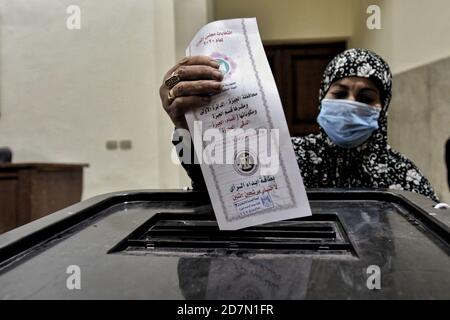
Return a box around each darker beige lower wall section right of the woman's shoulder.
[389,58,450,203]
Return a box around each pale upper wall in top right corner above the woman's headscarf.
[349,0,450,74]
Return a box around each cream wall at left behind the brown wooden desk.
[0,0,211,198]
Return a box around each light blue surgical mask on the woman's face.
[317,99,380,148]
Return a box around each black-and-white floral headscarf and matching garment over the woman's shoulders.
[292,49,438,201]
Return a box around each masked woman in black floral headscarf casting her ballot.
[160,49,438,201]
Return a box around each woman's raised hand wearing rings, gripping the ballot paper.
[159,56,223,129]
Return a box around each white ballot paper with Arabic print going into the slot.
[186,18,311,230]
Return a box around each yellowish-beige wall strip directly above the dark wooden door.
[214,0,352,42]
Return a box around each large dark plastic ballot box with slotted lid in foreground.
[0,189,450,300]
